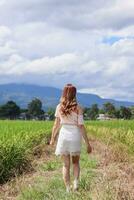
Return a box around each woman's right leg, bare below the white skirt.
[72,155,80,190]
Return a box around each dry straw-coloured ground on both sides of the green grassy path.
[0,139,134,200]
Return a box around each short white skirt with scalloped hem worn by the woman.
[55,124,82,155]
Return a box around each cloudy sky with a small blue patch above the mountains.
[0,0,134,102]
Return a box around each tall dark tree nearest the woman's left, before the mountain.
[28,98,44,117]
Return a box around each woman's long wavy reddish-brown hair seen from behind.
[60,83,77,116]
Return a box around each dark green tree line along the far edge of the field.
[0,98,134,120]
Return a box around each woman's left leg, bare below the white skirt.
[62,155,70,187]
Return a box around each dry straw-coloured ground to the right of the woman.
[91,139,134,200]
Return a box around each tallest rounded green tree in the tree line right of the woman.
[103,102,116,117]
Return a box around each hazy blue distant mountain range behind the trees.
[0,83,134,110]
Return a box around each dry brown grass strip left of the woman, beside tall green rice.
[0,145,57,200]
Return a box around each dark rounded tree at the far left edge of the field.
[0,101,20,119]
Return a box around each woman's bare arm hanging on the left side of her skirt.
[50,117,60,145]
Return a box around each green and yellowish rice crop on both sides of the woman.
[0,120,134,183]
